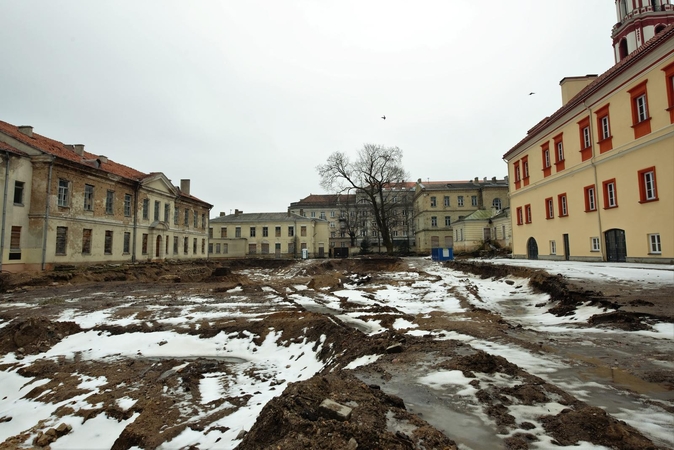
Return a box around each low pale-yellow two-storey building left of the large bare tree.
[208,209,329,258]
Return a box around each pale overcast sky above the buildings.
[0,0,616,217]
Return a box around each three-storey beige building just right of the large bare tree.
[414,177,509,253]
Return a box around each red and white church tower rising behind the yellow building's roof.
[611,0,674,63]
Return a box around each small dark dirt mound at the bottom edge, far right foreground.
[541,406,659,450]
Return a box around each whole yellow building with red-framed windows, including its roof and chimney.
[503,22,674,263]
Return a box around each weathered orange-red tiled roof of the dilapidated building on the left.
[0,120,146,181]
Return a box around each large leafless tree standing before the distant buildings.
[317,144,407,253]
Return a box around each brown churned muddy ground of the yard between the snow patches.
[0,258,674,449]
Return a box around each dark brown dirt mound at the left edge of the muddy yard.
[0,317,82,355]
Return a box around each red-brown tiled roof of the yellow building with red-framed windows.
[503,24,674,159]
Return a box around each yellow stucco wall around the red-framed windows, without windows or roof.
[508,44,674,262]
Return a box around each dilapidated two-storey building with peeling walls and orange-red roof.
[0,122,211,272]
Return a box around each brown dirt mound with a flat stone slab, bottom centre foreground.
[237,373,457,450]
